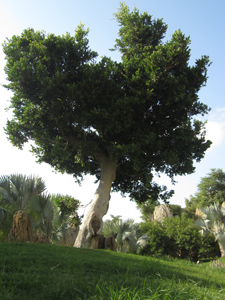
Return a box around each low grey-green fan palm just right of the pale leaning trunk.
[103,216,149,253]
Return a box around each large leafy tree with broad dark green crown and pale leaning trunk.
[3,3,210,247]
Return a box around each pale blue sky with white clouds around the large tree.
[0,0,225,222]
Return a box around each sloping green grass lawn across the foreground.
[0,242,225,300]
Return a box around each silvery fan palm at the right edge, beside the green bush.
[195,203,225,257]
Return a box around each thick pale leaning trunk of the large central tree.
[74,156,117,248]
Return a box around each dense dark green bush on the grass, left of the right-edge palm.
[140,215,220,261]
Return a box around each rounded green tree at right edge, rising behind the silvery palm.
[187,169,225,208]
